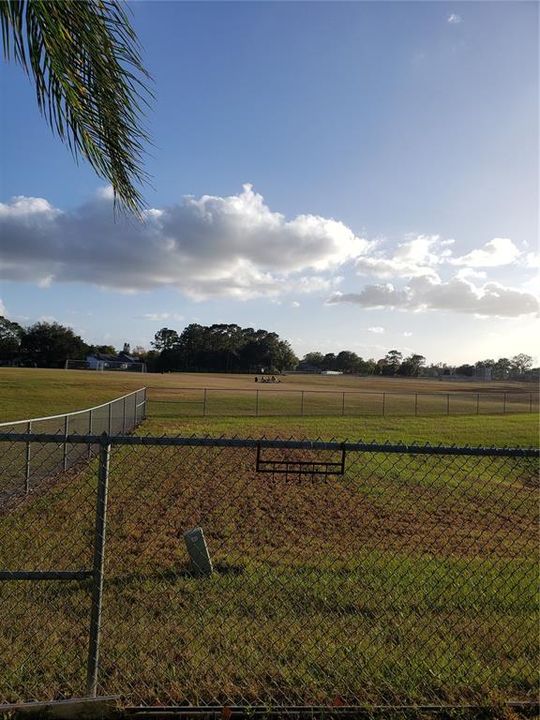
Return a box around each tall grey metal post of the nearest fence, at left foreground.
[86,433,111,697]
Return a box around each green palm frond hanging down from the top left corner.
[0,0,150,215]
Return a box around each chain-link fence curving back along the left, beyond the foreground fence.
[0,388,147,496]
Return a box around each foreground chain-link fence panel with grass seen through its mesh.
[0,432,539,708]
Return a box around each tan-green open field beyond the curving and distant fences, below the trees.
[0,368,538,434]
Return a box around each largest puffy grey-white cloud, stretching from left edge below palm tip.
[0,185,370,299]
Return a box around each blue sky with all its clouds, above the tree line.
[0,2,538,362]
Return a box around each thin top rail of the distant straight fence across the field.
[149,383,534,402]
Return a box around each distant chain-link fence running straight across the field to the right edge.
[149,386,539,417]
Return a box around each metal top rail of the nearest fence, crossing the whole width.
[0,432,540,459]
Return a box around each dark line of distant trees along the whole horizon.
[0,316,538,380]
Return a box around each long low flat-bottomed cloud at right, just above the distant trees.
[327,277,538,317]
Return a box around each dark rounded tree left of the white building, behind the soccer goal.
[21,322,88,367]
